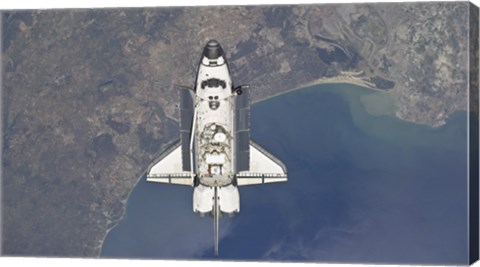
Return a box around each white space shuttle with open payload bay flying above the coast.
[147,40,287,257]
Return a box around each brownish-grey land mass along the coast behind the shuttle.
[2,2,478,257]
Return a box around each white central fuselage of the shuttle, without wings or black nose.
[192,51,240,216]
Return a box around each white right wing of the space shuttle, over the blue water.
[237,141,287,186]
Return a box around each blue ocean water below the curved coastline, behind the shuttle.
[102,84,468,264]
